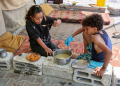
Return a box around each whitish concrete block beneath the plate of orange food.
[13,53,46,75]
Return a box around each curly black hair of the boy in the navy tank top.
[82,14,103,31]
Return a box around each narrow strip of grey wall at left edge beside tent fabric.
[0,6,6,36]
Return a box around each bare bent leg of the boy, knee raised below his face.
[83,31,91,53]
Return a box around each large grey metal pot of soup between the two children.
[53,49,72,65]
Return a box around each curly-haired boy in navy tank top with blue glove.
[65,14,112,76]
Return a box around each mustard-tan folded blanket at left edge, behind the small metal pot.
[0,32,25,53]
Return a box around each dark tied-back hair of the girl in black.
[25,5,43,19]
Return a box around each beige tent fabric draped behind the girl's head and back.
[2,0,35,34]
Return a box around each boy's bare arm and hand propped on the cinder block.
[91,35,112,76]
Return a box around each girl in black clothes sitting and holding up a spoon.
[25,5,61,57]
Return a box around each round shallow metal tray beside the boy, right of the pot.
[71,59,90,69]
